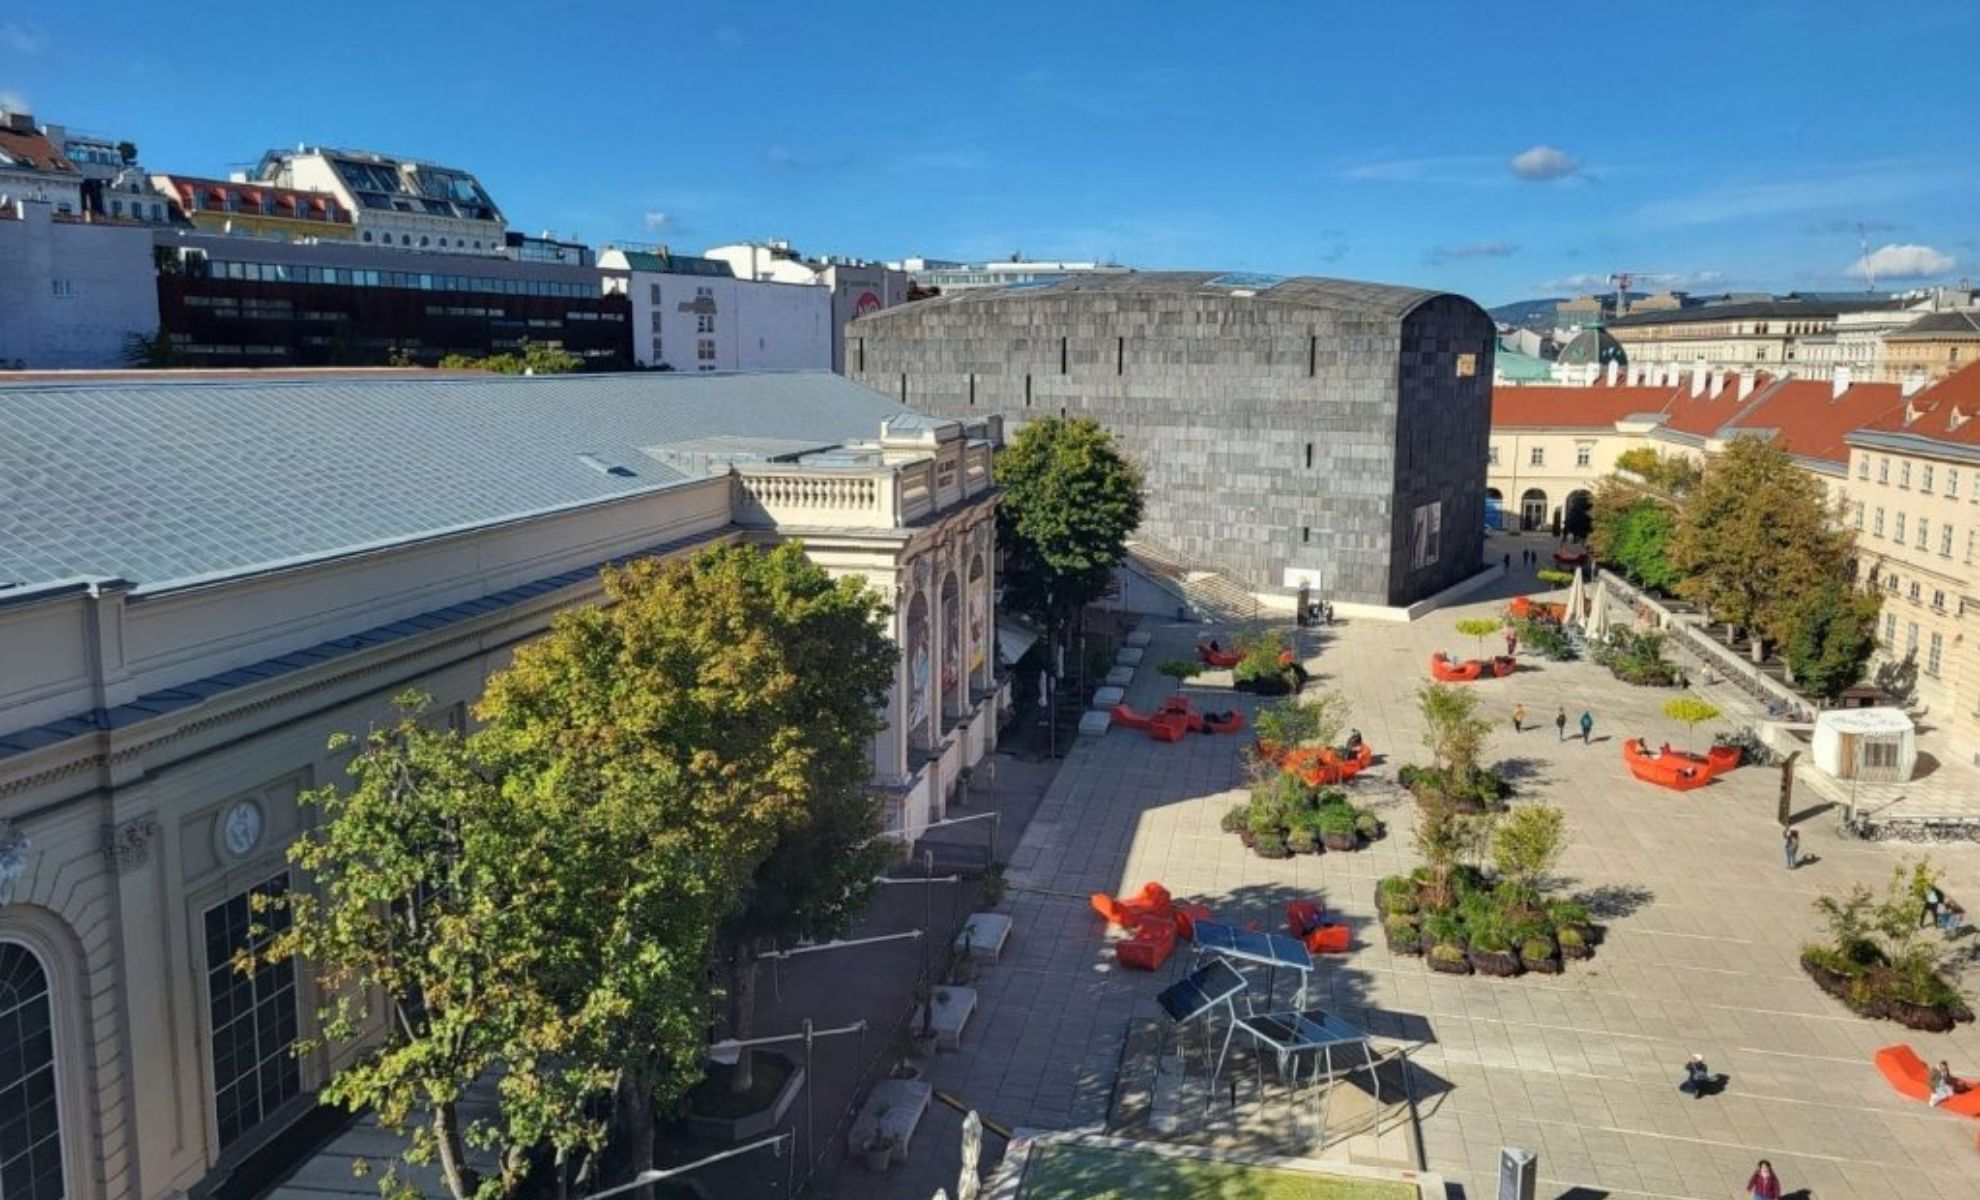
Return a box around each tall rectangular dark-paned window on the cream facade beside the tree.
[204,871,303,1147]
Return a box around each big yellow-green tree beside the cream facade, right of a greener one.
[477,543,897,1170]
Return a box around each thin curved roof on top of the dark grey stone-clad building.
[861,271,1443,321]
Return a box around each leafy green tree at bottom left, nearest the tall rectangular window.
[259,693,610,1200]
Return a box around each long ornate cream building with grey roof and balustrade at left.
[0,372,1010,1200]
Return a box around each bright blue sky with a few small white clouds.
[0,0,1980,303]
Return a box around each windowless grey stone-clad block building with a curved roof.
[845,271,1495,608]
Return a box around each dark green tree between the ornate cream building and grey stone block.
[996,418,1142,645]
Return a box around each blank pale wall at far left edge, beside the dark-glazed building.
[0,202,158,368]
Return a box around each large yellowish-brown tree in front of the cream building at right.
[1671,438,1853,642]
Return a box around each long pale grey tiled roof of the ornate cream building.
[0,372,907,596]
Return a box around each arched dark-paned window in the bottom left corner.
[0,943,63,1200]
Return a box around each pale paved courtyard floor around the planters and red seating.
[863,558,1980,1200]
